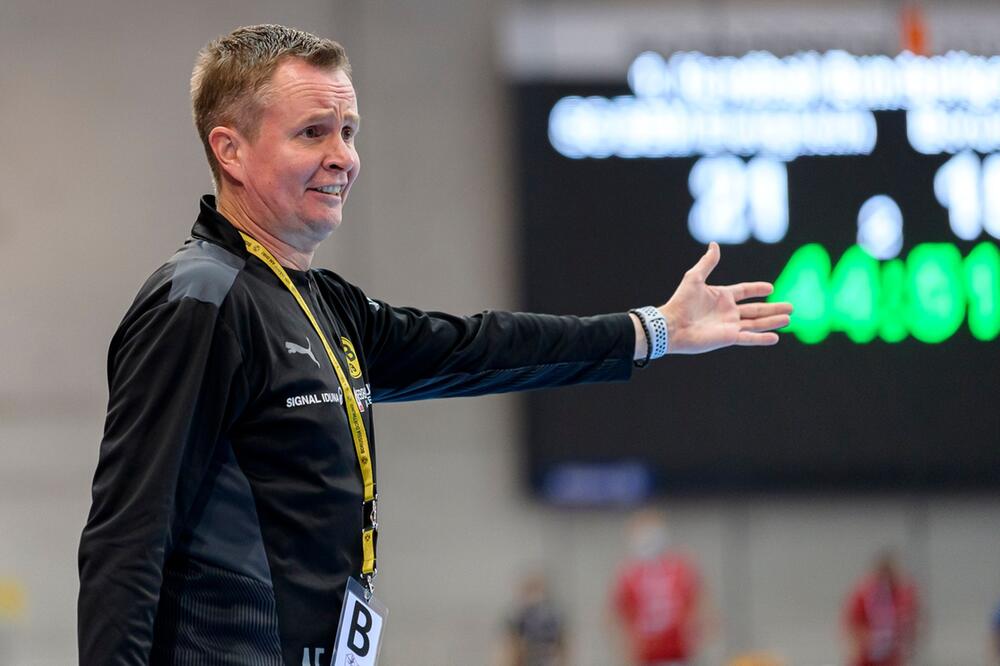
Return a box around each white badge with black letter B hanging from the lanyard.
[330,578,389,666]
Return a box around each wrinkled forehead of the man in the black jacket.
[265,58,358,117]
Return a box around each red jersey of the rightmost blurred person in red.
[844,576,917,666]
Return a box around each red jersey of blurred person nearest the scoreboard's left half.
[614,554,700,664]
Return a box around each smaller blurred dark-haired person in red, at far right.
[844,550,920,666]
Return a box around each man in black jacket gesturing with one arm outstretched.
[79,26,790,666]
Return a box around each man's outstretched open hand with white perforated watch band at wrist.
[632,242,792,359]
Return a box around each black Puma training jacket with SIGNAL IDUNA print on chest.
[78,197,635,666]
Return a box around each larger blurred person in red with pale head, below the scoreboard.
[611,509,705,666]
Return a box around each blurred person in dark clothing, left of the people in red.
[503,571,570,666]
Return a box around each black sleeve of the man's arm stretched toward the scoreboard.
[352,299,635,402]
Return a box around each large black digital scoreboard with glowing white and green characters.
[512,51,1000,503]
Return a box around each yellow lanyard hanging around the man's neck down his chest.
[240,231,378,590]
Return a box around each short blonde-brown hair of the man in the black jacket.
[191,25,351,189]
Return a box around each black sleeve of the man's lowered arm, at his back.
[78,298,247,666]
